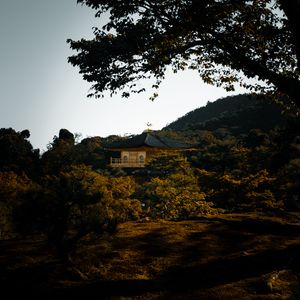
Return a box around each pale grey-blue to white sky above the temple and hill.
[0,0,245,151]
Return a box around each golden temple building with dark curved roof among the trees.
[106,130,191,168]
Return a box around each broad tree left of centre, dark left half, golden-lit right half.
[15,164,141,261]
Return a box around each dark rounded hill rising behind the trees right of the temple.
[163,94,286,134]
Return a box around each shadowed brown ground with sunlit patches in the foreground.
[0,213,300,300]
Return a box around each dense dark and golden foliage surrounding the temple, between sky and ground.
[0,97,300,259]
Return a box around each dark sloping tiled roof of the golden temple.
[106,132,191,149]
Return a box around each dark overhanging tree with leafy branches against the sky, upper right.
[68,0,300,108]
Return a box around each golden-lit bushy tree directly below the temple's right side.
[137,153,216,219]
